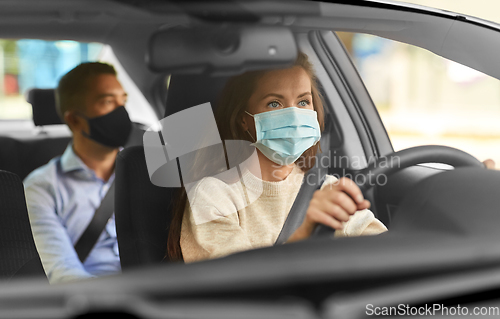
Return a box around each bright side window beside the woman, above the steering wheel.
[337,32,500,168]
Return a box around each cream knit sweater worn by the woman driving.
[180,166,387,262]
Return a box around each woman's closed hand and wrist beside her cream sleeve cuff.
[288,177,370,242]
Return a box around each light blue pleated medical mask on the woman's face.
[245,107,321,165]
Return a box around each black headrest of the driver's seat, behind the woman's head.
[165,74,229,117]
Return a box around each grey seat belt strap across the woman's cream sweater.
[275,166,327,245]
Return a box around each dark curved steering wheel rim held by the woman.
[314,145,484,236]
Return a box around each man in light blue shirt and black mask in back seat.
[24,62,132,283]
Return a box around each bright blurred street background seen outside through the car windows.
[0,0,500,166]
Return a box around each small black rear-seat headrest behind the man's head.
[27,89,63,126]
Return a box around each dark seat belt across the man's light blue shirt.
[75,181,115,263]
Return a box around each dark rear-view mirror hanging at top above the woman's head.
[146,25,297,75]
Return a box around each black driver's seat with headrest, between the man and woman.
[115,75,227,270]
